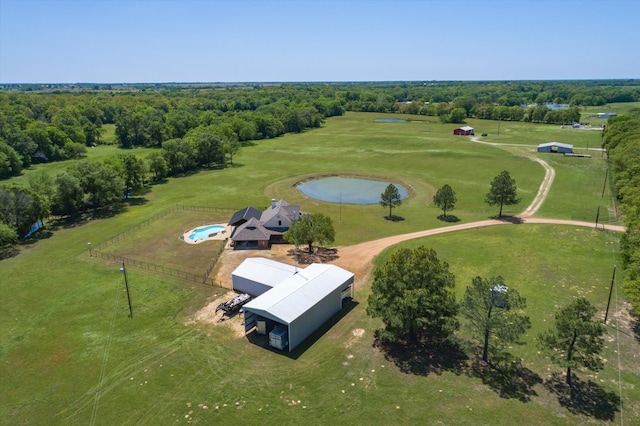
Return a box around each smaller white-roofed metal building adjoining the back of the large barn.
[231,257,297,296]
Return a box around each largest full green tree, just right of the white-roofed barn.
[367,246,459,342]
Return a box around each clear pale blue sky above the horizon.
[0,0,640,83]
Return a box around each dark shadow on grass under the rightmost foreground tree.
[544,373,619,421]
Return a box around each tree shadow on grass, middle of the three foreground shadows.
[469,353,542,402]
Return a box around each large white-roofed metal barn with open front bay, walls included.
[244,263,354,351]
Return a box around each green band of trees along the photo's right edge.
[605,108,640,315]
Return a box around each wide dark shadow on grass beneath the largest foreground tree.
[373,333,468,376]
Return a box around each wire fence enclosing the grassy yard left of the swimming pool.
[90,204,239,286]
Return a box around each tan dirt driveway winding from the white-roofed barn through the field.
[216,137,625,288]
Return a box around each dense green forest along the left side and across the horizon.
[0,80,640,247]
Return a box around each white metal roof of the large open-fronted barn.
[244,263,354,324]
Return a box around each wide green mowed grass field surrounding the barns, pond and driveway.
[0,113,640,425]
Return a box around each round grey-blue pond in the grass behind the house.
[297,176,409,204]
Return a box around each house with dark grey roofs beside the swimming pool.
[229,200,301,249]
